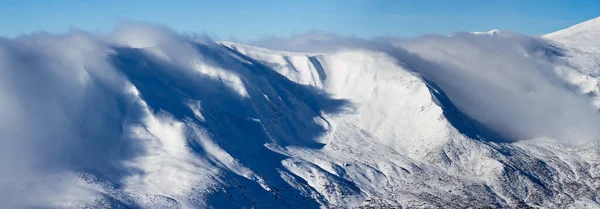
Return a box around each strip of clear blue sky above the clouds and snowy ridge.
[0,0,600,40]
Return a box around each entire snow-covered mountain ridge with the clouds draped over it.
[0,19,600,208]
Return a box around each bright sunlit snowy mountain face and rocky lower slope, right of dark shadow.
[223,38,598,208]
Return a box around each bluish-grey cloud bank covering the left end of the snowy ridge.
[0,23,218,208]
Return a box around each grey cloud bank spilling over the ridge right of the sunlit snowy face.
[249,32,600,142]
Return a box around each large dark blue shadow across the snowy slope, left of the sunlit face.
[111,43,349,208]
